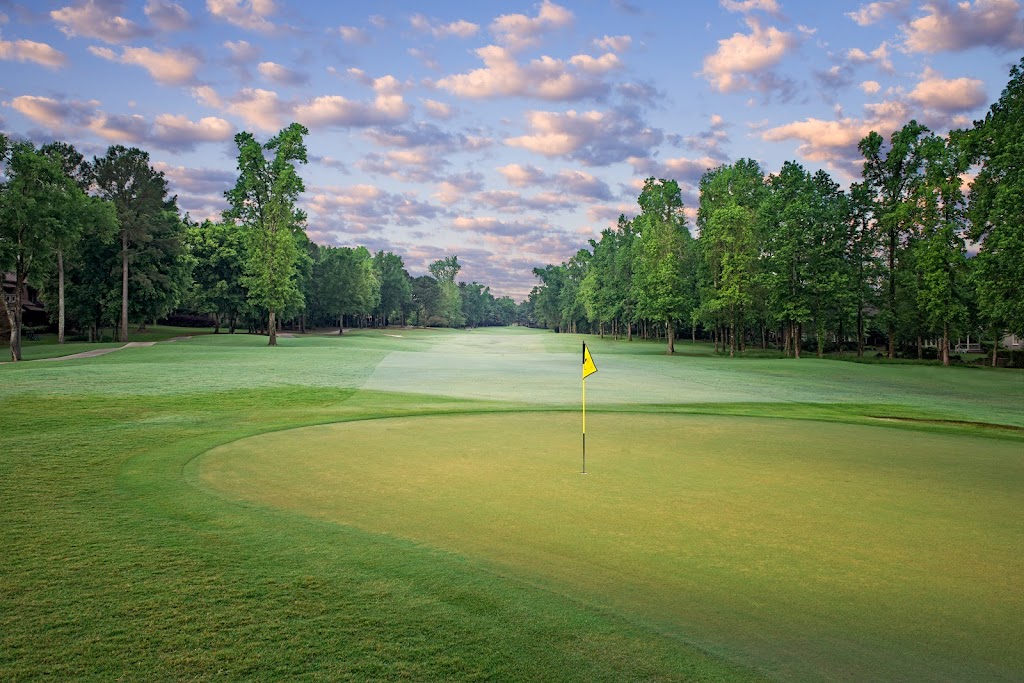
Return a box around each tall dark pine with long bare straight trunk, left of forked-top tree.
[92,144,177,341]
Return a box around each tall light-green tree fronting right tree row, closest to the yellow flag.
[633,178,693,354]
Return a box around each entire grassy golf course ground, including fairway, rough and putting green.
[0,327,1024,681]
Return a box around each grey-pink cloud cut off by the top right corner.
[903,0,1024,53]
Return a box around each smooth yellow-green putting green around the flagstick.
[190,413,1024,680]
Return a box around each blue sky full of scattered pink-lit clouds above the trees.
[0,0,1024,300]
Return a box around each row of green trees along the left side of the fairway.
[0,124,520,360]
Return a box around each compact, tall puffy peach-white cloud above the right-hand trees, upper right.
[700,18,798,92]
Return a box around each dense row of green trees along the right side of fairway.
[527,59,1024,365]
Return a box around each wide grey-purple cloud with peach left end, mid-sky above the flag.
[505,108,665,166]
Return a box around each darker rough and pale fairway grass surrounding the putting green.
[0,331,1024,680]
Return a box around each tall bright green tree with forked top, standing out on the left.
[224,123,309,346]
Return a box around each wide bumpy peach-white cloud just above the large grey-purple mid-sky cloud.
[436,45,622,101]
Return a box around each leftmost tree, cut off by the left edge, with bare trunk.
[0,138,81,360]
